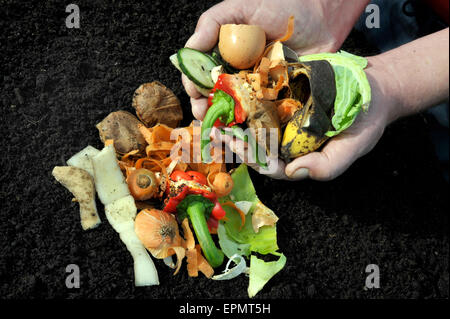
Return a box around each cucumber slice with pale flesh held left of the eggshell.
[177,48,217,89]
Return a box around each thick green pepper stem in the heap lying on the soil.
[187,202,224,268]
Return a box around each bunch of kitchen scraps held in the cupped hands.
[170,16,371,164]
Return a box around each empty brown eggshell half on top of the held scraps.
[219,24,266,70]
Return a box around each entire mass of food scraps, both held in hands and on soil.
[53,17,371,297]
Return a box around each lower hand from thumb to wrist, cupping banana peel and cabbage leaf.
[285,57,397,181]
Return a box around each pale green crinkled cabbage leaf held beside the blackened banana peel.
[299,51,371,137]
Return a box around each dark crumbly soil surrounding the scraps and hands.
[0,0,449,299]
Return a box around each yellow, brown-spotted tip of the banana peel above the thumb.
[281,112,328,160]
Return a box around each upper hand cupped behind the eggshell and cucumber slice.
[182,0,369,120]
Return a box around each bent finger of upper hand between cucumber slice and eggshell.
[185,2,240,52]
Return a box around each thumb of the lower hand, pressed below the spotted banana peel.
[286,138,360,181]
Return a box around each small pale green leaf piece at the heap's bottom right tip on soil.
[247,253,286,298]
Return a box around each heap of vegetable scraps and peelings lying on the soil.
[52,82,286,297]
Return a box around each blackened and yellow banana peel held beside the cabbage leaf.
[281,60,336,161]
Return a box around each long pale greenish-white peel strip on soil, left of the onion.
[92,145,159,286]
